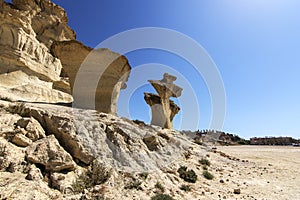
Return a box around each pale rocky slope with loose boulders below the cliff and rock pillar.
[0,101,201,199]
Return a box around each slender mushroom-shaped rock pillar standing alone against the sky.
[144,73,182,129]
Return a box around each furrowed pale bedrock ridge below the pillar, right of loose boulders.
[8,103,190,171]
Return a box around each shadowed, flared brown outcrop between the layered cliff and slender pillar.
[51,41,131,114]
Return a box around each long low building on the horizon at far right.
[250,137,294,145]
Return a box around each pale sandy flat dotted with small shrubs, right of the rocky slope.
[102,146,300,200]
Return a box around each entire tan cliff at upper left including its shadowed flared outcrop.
[0,0,131,111]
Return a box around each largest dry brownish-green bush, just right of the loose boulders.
[72,160,111,193]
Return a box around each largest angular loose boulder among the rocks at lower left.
[26,135,75,171]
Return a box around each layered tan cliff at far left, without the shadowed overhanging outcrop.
[0,0,75,103]
